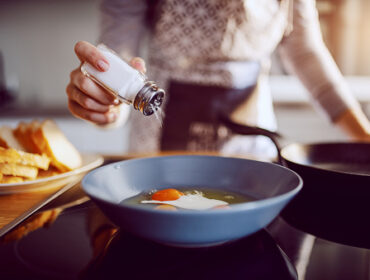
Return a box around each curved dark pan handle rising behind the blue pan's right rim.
[219,115,286,165]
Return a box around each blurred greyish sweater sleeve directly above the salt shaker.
[99,0,147,61]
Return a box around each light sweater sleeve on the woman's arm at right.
[279,0,359,122]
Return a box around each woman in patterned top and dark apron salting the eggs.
[67,0,370,160]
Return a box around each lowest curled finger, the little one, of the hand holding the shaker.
[68,99,117,124]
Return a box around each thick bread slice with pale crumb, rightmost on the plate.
[32,120,81,172]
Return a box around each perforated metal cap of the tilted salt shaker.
[133,81,164,116]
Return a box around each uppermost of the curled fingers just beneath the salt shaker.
[71,68,119,105]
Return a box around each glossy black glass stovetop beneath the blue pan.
[0,186,370,280]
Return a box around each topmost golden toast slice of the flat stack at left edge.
[0,147,50,170]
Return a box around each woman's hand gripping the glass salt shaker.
[66,41,145,125]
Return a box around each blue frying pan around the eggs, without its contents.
[82,155,302,247]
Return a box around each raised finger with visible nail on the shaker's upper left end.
[75,41,109,71]
